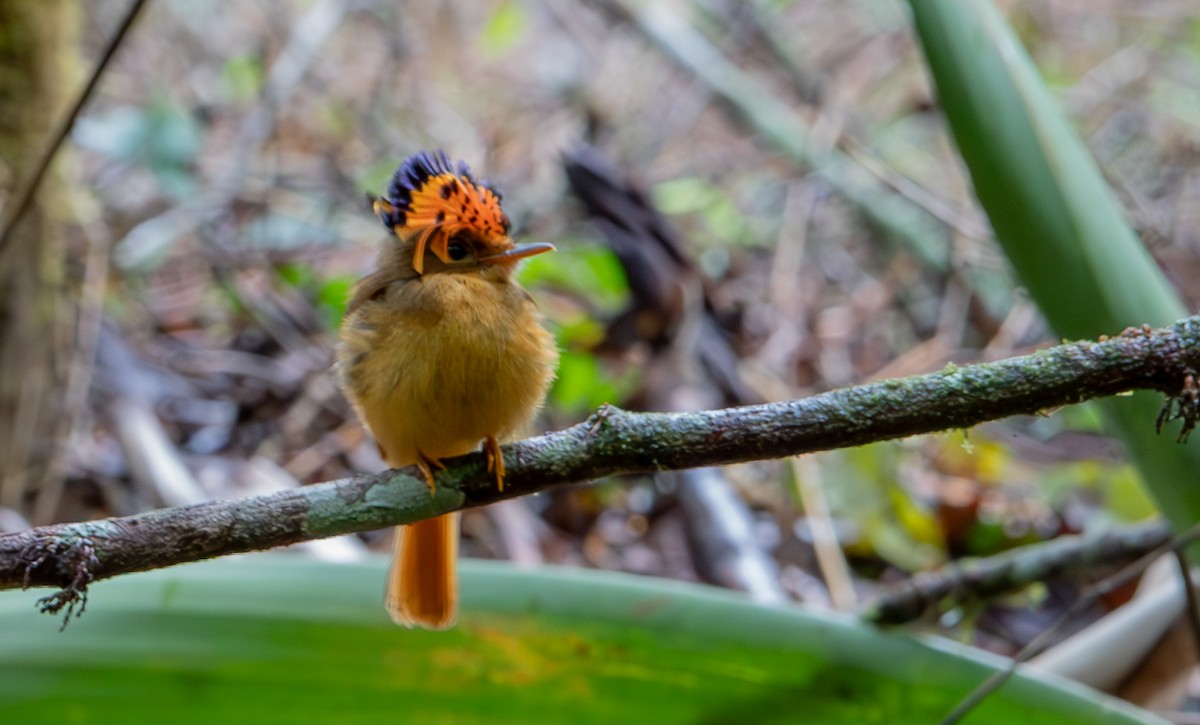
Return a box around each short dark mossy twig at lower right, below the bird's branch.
[862,521,1171,624]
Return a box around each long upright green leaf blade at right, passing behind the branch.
[910,0,1200,528]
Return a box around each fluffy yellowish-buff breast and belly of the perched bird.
[340,274,558,466]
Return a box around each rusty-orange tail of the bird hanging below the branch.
[384,513,460,629]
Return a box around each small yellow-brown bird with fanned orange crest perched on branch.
[335,149,558,630]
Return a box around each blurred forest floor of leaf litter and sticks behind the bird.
[0,0,1200,700]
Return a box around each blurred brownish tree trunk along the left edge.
[0,0,79,515]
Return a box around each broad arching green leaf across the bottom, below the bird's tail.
[0,553,1164,725]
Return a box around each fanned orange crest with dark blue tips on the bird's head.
[374,149,512,274]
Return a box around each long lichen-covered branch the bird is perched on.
[0,317,1200,615]
